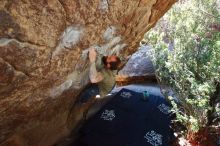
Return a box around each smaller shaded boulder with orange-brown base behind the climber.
[116,45,157,86]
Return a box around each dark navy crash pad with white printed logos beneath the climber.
[72,89,173,146]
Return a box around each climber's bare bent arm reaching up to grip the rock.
[89,48,103,83]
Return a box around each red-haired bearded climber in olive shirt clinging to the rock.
[80,48,121,103]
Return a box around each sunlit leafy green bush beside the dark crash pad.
[145,0,220,135]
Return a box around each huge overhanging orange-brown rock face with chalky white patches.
[0,0,175,146]
